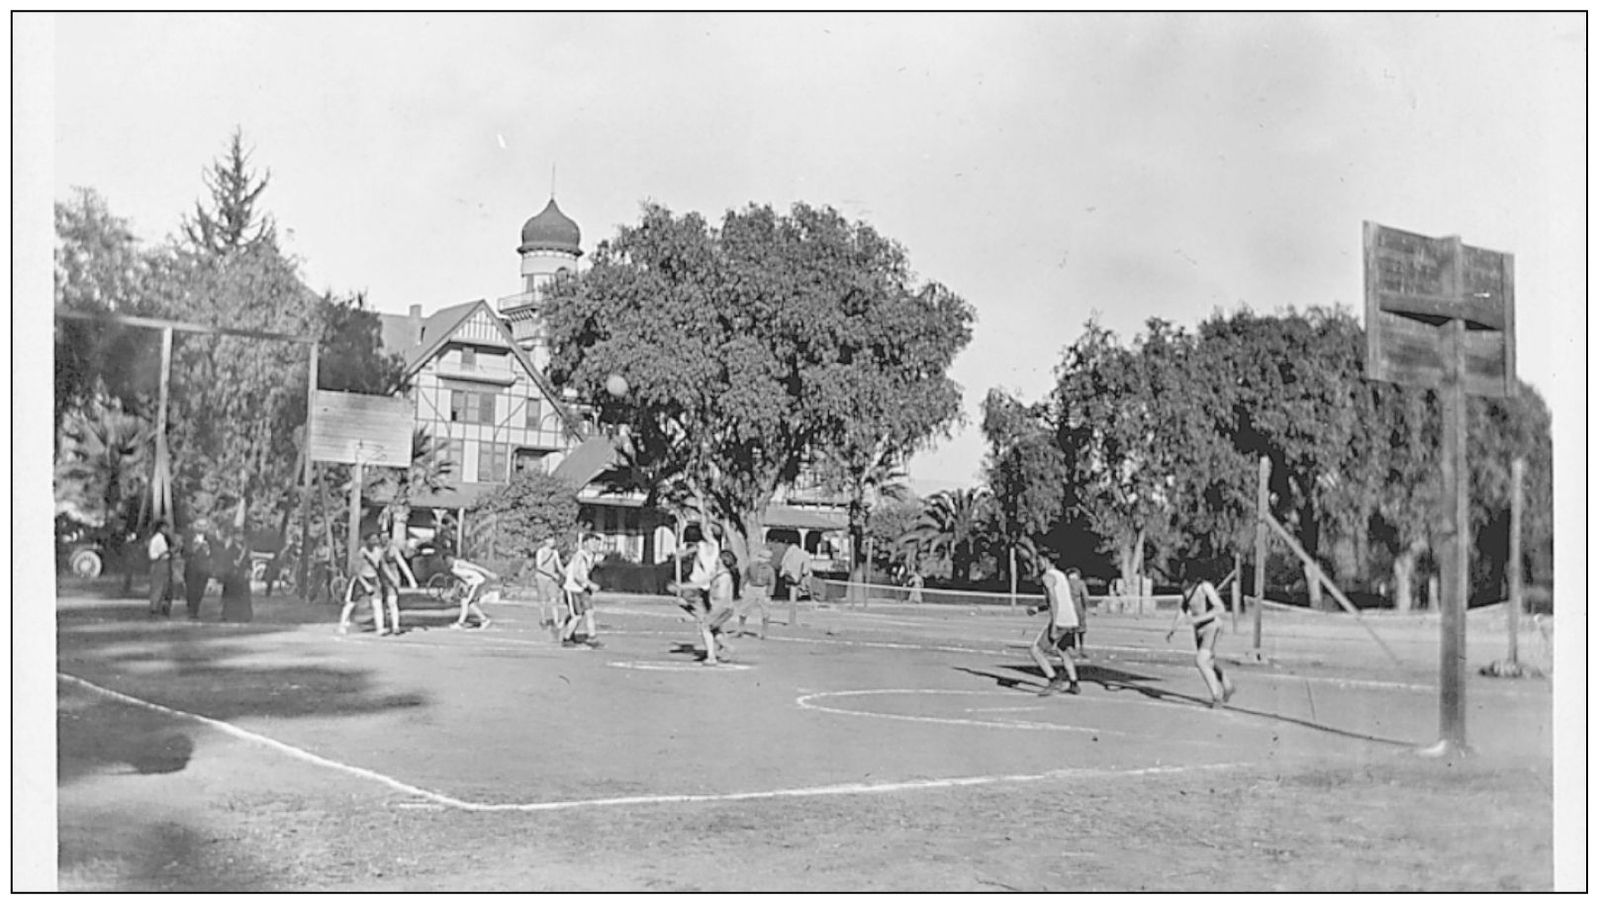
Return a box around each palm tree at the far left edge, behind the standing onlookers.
[53,396,155,589]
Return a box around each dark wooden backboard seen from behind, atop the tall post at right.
[1364,222,1516,398]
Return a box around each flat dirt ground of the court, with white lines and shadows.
[56,594,1554,891]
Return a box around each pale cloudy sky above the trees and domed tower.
[37,14,1586,492]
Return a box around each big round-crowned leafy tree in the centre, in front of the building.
[545,204,973,553]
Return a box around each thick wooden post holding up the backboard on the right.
[1439,318,1469,752]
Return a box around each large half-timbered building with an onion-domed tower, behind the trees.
[382,198,848,562]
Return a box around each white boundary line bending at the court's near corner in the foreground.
[56,672,1249,813]
